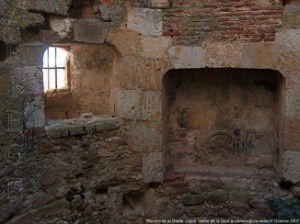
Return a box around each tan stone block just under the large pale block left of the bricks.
[141,37,172,58]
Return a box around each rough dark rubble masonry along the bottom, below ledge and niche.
[0,117,298,224]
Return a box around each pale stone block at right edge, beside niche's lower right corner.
[282,151,300,183]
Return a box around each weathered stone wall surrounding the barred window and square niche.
[0,0,300,224]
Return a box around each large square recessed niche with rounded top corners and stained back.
[163,69,283,173]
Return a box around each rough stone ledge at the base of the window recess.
[45,116,122,138]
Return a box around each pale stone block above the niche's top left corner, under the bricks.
[168,46,206,69]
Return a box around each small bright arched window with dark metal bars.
[43,47,68,92]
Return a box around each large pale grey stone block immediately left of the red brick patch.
[127,8,162,36]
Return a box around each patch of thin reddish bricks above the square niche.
[163,0,283,45]
